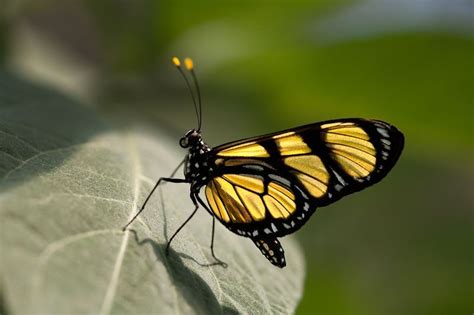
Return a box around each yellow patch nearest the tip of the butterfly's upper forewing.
[321,123,377,178]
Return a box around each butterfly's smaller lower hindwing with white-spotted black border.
[205,160,315,238]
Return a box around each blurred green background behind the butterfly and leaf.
[0,0,474,315]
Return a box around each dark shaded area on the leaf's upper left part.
[0,69,107,191]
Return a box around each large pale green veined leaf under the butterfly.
[0,73,304,314]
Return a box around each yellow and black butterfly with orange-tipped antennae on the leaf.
[124,57,404,268]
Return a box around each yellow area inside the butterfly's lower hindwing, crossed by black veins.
[206,174,296,223]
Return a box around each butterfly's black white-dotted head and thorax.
[180,132,213,192]
